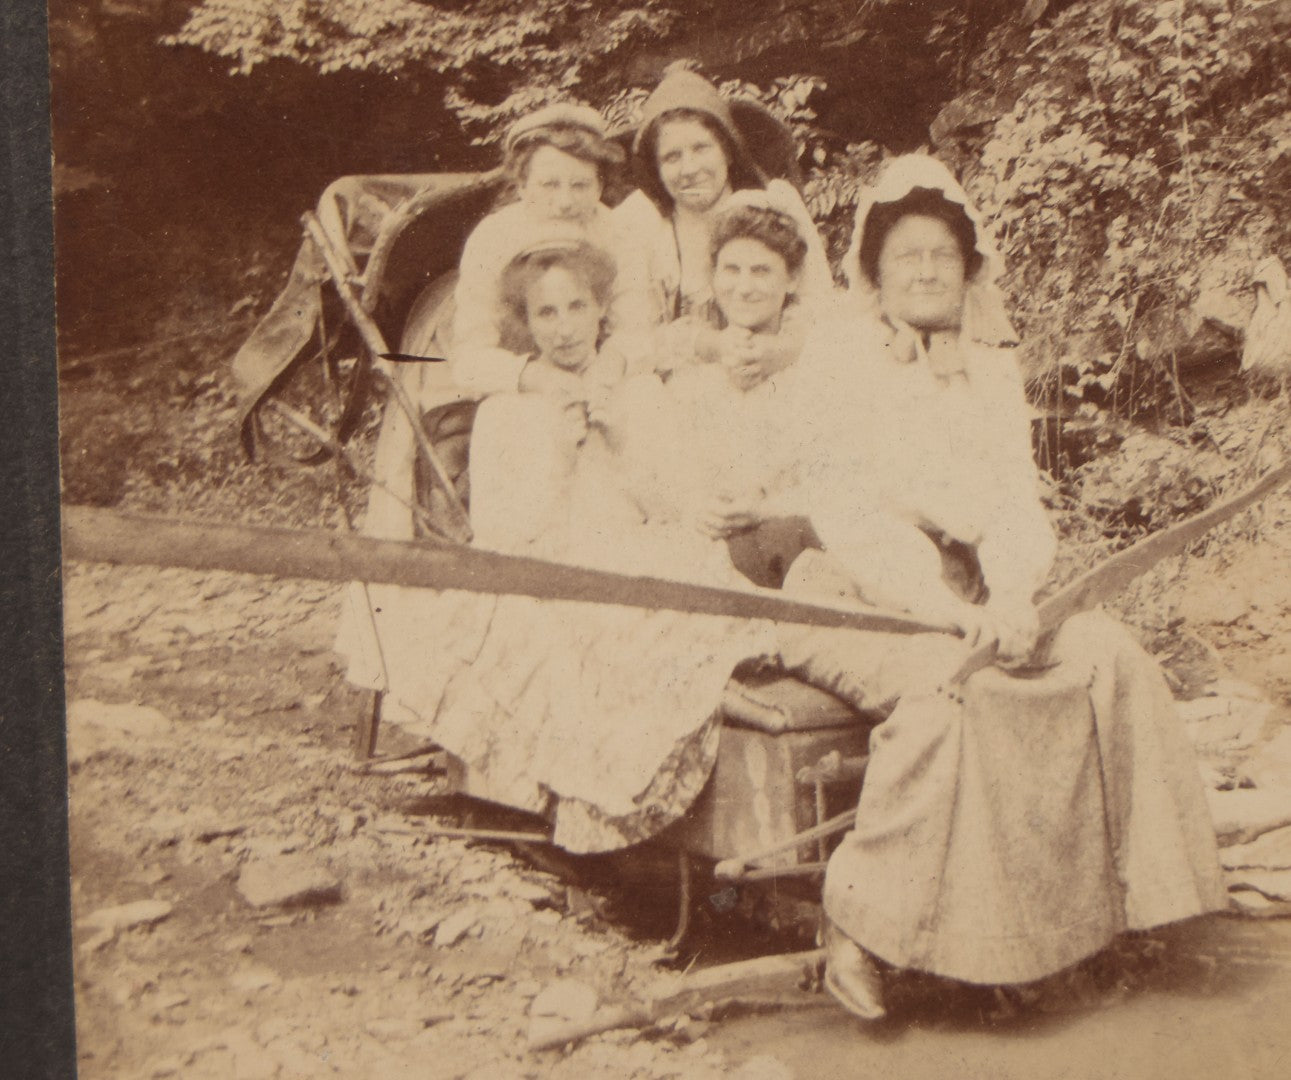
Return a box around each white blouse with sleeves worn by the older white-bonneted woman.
[782,317,1056,606]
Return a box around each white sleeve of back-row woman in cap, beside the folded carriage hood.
[449,210,525,394]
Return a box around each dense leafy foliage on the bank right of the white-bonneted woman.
[963,0,1291,413]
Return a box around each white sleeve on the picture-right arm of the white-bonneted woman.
[977,350,1057,603]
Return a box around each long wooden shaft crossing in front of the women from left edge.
[63,506,954,634]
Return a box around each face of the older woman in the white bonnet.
[878,214,964,330]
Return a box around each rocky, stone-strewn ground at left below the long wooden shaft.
[66,566,815,1080]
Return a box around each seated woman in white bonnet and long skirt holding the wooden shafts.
[781,155,1226,1019]
